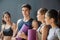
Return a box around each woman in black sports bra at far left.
[1,11,17,40]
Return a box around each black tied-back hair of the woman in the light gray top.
[47,9,58,24]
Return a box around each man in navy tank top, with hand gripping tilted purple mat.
[17,4,37,39]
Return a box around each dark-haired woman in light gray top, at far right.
[45,9,60,40]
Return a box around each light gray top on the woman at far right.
[47,27,60,40]
